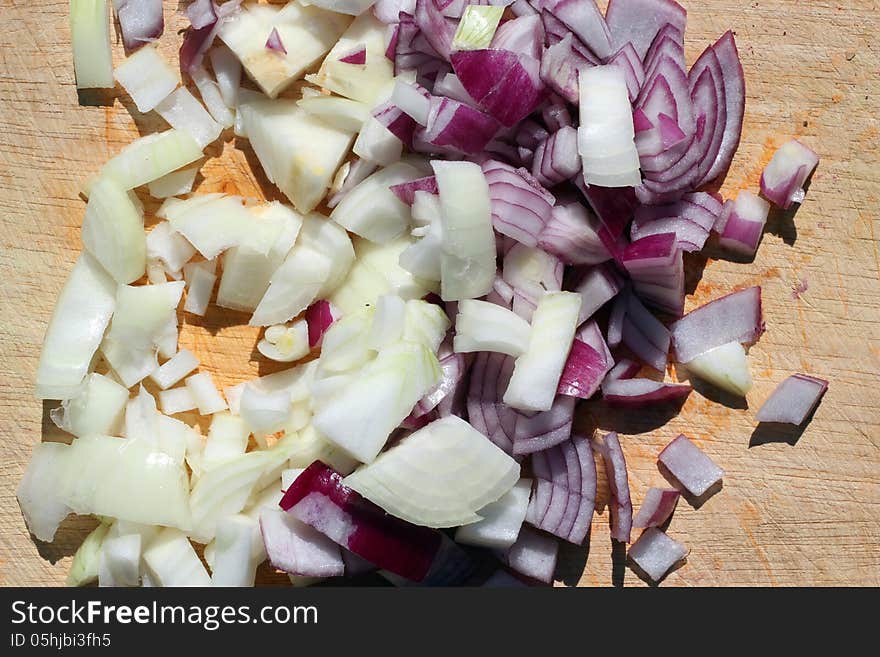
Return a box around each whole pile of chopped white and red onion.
[18,0,828,586]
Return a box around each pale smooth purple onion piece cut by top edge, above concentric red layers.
[605,0,687,59]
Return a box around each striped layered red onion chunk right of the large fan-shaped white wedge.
[526,436,596,545]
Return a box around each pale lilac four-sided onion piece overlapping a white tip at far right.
[670,287,764,363]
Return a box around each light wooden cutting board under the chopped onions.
[0,0,880,586]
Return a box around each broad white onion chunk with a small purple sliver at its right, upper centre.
[330,162,421,244]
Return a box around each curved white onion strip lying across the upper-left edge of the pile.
[101,128,202,189]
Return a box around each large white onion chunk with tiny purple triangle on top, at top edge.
[218,3,350,98]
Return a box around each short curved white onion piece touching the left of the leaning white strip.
[454,299,531,358]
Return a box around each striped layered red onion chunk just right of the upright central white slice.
[483,160,556,247]
